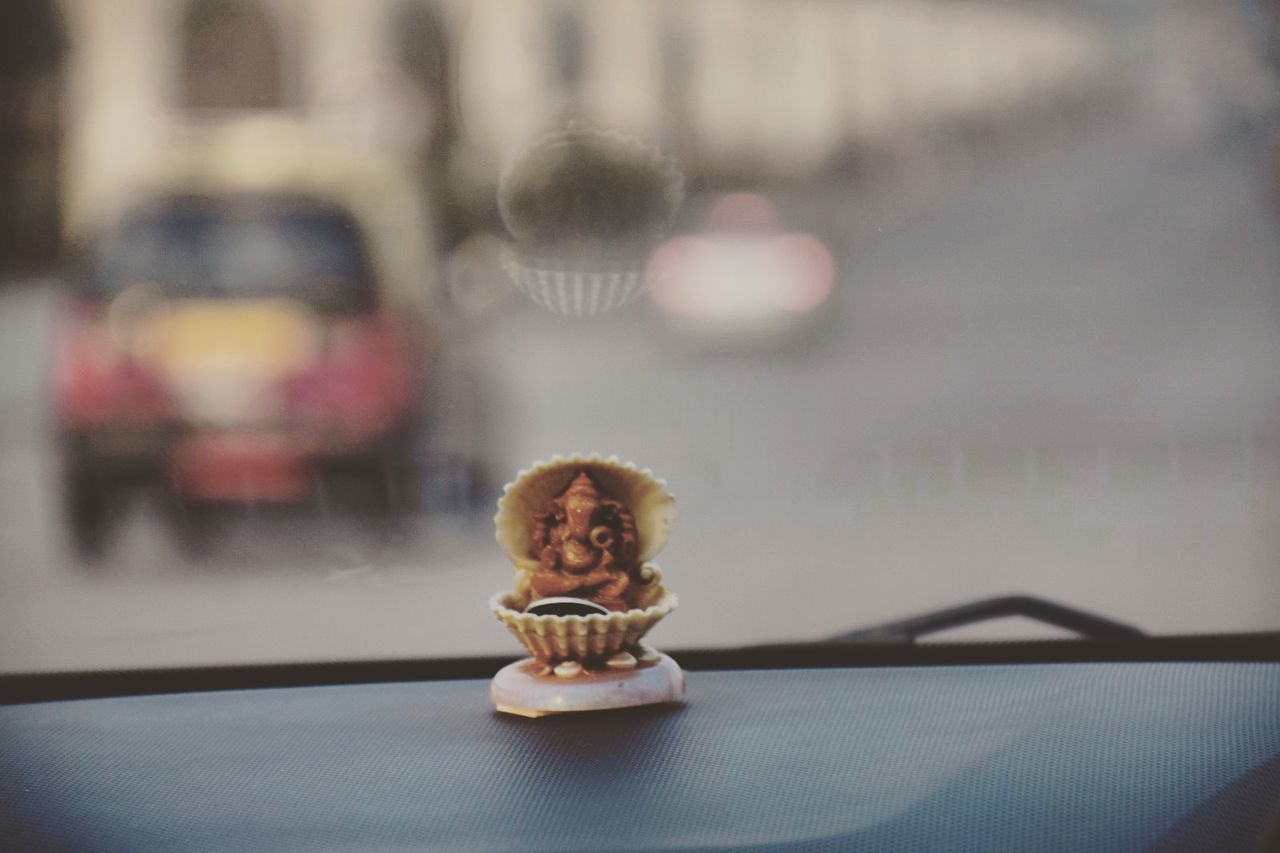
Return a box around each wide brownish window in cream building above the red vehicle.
[182,0,285,110]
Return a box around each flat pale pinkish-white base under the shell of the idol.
[489,653,685,717]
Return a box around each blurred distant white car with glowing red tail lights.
[649,193,835,348]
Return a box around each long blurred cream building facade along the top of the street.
[56,0,1100,266]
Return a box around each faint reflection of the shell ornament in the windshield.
[498,120,685,316]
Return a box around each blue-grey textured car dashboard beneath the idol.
[0,663,1280,853]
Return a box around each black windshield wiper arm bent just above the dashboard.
[827,596,1147,644]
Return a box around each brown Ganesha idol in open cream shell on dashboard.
[490,455,685,716]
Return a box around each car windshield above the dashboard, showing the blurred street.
[0,0,1280,671]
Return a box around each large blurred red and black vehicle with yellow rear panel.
[55,193,425,556]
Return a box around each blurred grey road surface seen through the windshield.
[0,58,1280,670]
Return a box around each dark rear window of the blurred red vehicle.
[88,205,372,311]
